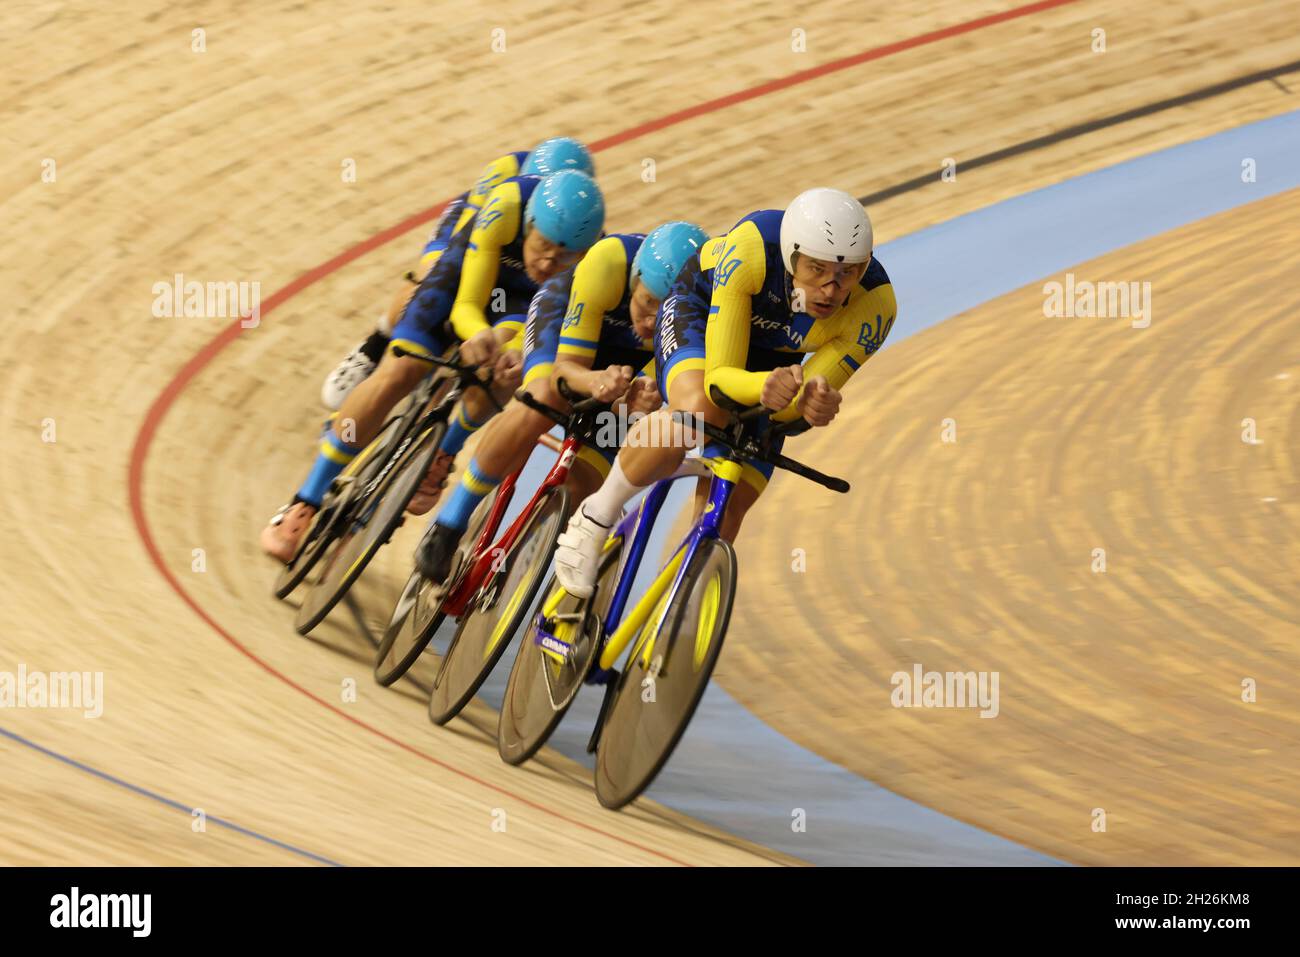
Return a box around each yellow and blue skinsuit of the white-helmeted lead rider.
[654,209,897,490]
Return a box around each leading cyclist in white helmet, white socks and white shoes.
[555,189,896,597]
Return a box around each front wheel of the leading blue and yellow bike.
[595,538,736,809]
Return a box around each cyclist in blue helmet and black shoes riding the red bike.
[416,221,709,581]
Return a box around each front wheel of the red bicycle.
[429,488,569,724]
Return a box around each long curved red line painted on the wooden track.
[127,0,1078,866]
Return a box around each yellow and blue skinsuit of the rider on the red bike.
[524,233,654,476]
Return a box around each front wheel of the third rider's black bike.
[294,423,447,635]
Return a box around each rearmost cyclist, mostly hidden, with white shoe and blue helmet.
[321,137,595,410]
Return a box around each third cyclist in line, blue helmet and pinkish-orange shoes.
[261,169,605,562]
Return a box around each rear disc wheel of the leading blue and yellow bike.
[497,541,623,765]
